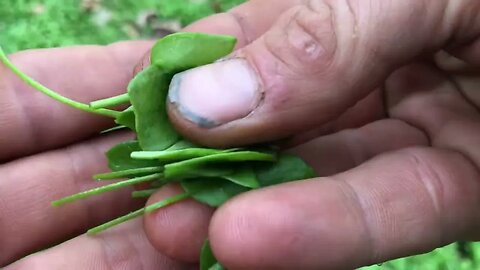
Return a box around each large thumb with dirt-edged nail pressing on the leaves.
[169,0,480,147]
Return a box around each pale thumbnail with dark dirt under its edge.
[169,58,260,128]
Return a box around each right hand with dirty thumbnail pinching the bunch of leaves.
[145,0,480,269]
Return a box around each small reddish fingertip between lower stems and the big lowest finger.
[144,185,213,262]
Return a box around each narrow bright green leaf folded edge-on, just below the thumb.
[164,151,275,178]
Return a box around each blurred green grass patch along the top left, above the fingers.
[0,0,242,52]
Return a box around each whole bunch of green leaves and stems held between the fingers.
[0,33,314,270]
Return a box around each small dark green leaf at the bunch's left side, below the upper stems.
[106,141,160,172]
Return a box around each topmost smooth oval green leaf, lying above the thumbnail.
[151,32,237,73]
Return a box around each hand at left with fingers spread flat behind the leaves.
[0,42,195,270]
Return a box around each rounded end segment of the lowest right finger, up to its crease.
[209,179,366,269]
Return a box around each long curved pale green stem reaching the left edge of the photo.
[0,47,120,118]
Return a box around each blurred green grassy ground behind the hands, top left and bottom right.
[0,0,480,270]
